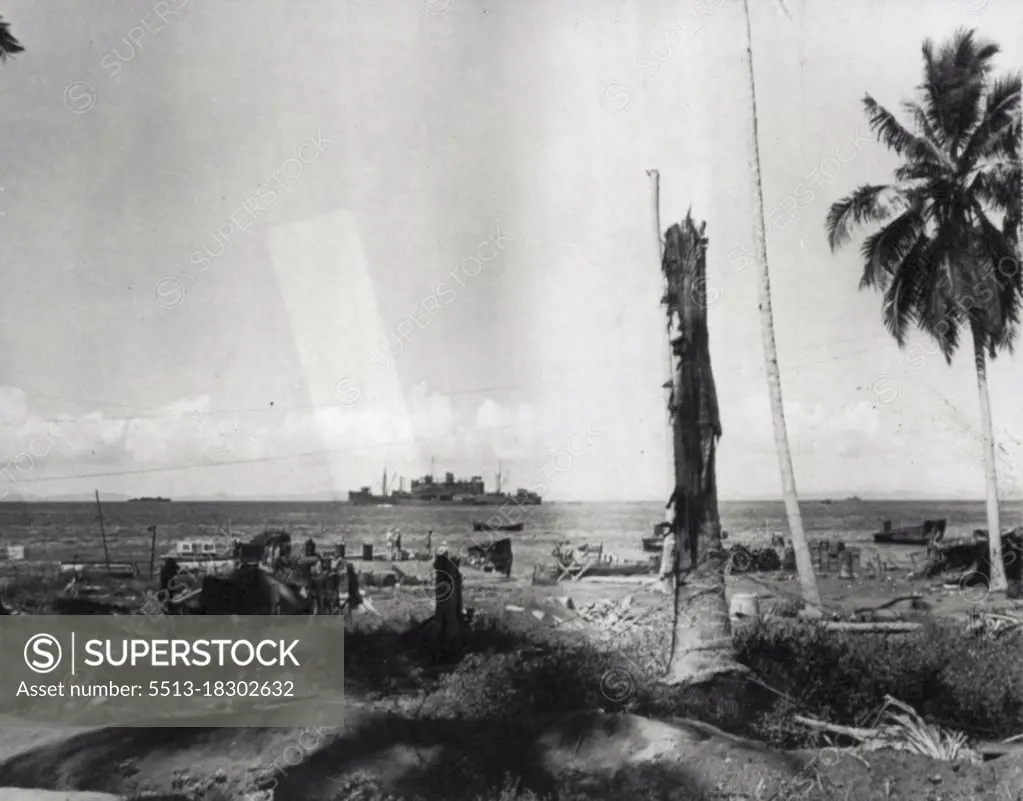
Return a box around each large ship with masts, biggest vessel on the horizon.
[348,468,543,506]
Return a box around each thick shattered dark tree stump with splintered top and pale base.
[662,214,746,684]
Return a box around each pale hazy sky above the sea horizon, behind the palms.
[0,0,1023,500]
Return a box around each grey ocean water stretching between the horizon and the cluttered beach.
[0,501,1010,573]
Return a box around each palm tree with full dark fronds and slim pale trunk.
[827,31,1023,590]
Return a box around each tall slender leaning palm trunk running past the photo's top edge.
[743,0,821,617]
